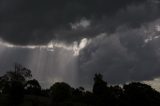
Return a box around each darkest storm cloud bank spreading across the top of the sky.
[0,0,159,45]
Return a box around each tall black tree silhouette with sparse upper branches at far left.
[0,64,32,105]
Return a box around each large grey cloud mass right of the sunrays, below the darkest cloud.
[79,21,160,84]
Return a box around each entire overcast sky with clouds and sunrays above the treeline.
[0,0,160,89]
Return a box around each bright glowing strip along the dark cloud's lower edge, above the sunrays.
[0,38,91,56]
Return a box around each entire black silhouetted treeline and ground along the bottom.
[0,64,160,106]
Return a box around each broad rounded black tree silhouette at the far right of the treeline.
[124,82,160,106]
